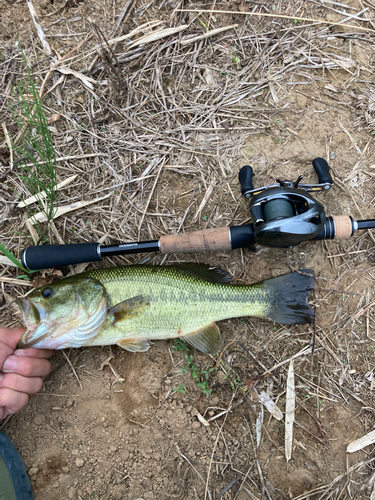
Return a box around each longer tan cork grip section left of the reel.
[160,227,232,253]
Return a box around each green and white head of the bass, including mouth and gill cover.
[17,276,108,349]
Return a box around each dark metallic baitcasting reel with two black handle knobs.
[239,158,333,248]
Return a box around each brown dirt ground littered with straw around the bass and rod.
[0,0,375,500]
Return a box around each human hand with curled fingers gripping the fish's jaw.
[0,328,52,420]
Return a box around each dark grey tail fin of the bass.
[263,269,315,325]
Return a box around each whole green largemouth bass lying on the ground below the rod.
[18,264,315,352]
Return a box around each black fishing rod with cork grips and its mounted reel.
[21,158,375,271]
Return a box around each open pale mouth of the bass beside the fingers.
[16,298,48,347]
